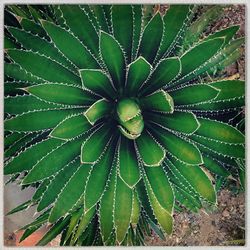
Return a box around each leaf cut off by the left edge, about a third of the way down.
[4,63,44,84]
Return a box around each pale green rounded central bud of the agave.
[116,98,144,139]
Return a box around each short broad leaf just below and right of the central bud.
[135,130,166,166]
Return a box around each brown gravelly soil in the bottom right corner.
[146,190,245,246]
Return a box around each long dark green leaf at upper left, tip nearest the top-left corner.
[9,28,76,72]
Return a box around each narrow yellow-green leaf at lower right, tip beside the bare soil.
[144,176,173,234]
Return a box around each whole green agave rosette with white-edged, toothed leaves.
[4,5,244,245]
